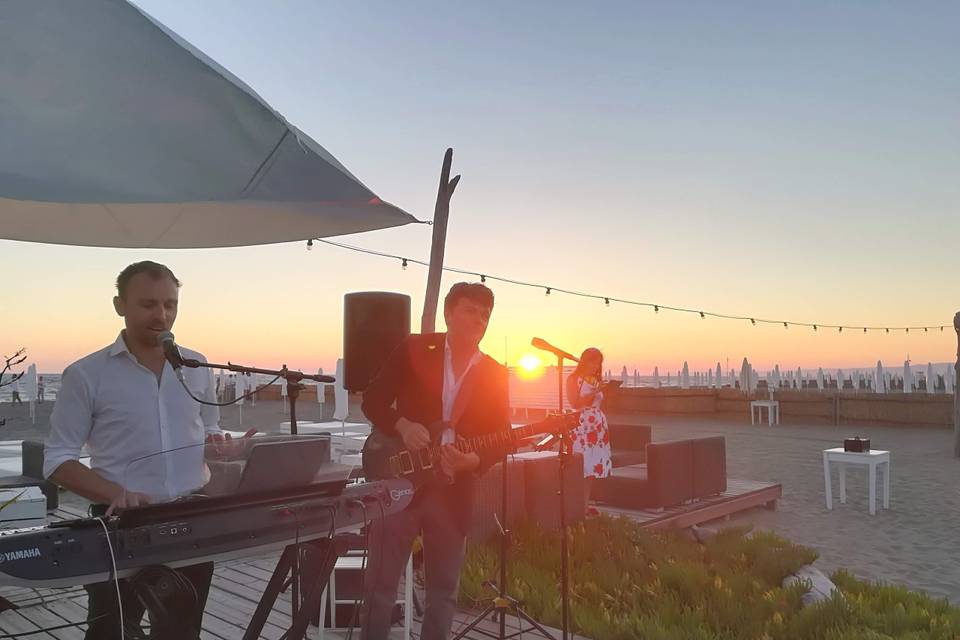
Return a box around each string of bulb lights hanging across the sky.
[313,238,947,333]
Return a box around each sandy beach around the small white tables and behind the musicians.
[0,401,960,603]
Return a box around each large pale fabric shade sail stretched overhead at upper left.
[0,0,415,248]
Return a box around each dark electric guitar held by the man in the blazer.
[362,411,580,488]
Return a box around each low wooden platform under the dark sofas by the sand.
[599,478,783,529]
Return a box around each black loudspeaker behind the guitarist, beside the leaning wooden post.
[343,291,410,391]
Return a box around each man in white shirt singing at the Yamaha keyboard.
[43,261,223,640]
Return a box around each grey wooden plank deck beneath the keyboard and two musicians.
[0,508,586,640]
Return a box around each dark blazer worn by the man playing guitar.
[362,333,510,522]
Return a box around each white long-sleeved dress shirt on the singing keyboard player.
[43,332,220,501]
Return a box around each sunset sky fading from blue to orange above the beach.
[0,0,960,374]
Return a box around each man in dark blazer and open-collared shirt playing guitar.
[362,282,510,640]
